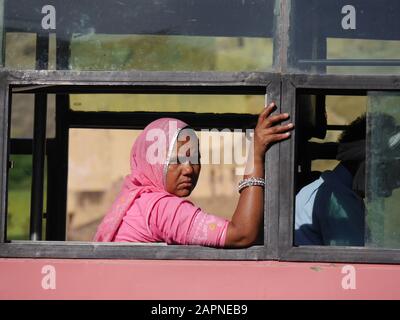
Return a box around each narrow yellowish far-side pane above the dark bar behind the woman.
[70,94,264,114]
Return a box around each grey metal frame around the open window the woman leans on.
[0,70,281,260]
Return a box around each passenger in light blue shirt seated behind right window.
[295,115,366,246]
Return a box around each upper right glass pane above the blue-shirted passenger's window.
[289,0,400,74]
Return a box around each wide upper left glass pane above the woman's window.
[5,0,275,71]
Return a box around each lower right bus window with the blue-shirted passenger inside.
[294,92,400,248]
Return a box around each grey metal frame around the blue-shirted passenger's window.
[279,74,400,264]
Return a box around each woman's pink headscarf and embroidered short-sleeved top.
[94,118,229,247]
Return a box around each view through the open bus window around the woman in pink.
[7,88,265,241]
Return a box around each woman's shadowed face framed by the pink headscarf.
[166,130,201,197]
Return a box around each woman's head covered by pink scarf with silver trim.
[131,118,200,197]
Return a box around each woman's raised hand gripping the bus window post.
[254,102,293,158]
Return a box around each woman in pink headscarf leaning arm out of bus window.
[94,103,293,248]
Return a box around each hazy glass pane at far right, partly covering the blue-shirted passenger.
[366,92,400,248]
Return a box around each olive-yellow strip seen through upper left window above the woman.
[70,34,273,71]
